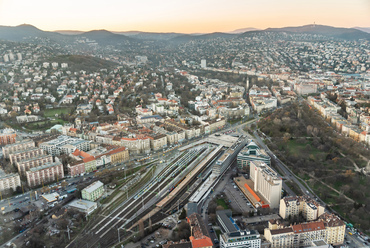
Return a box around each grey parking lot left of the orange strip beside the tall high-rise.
[225,179,255,213]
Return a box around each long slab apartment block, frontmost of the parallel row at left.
[26,160,64,187]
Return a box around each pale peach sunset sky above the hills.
[0,0,370,33]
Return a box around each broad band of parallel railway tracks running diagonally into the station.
[67,146,213,247]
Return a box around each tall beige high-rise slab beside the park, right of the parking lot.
[250,161,282,208]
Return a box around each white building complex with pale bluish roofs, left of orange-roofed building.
[40,135,91,156]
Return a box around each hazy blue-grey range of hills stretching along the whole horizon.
[0,24,370,45]
